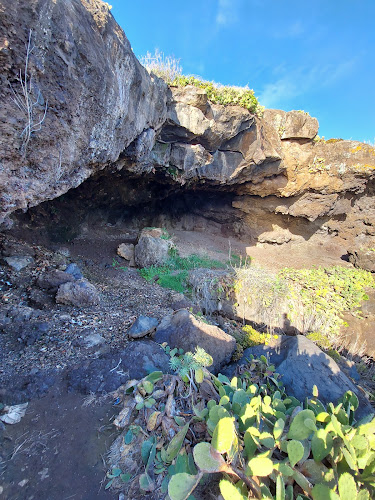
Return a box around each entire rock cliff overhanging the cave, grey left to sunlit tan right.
[0,0,375,252]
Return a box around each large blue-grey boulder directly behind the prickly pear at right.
[224,335,375,418]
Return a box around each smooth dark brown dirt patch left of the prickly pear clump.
[0,378,118,500]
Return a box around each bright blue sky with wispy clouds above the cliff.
[109,0,375,143]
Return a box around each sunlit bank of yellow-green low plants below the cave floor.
[225,266,375,339]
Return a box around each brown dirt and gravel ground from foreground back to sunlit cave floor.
[0,228,374,500]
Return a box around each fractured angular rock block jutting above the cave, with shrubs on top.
[154,86,284,184]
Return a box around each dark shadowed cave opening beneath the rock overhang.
[10,167,245,258]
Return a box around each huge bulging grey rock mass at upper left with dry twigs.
[0,0,167,223]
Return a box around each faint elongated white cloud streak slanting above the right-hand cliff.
[259,59,356,108]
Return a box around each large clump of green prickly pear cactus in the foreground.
[109,349,375,500]
